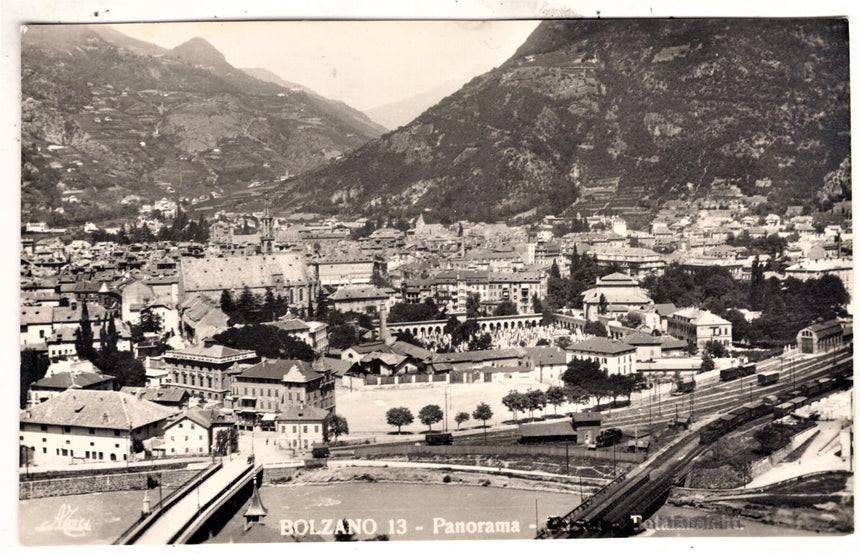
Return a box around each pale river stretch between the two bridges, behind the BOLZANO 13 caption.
[209,482,579,543]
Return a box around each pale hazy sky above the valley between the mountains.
[107,21,538,110]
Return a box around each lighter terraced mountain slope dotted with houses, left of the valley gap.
[21,25,384,221]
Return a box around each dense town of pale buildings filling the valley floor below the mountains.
[20,187,853,542]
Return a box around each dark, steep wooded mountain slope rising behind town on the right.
[279,19,850,224]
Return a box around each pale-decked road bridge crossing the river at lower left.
[114,455,262,545]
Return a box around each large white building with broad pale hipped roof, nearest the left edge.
[19,389,175,465]
